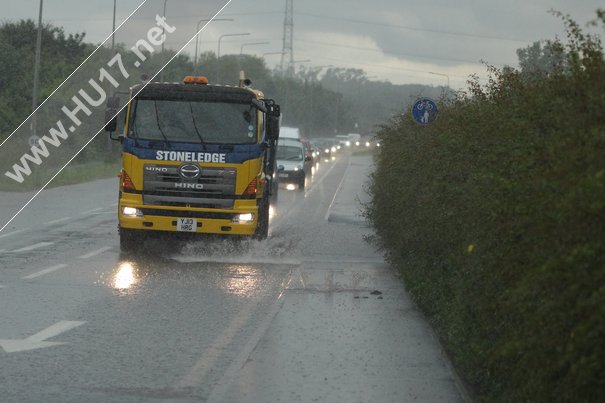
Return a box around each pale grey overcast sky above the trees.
[0,0,605,88]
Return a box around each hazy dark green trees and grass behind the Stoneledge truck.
[0,20,442,191]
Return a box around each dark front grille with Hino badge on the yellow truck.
[143,163,237,209]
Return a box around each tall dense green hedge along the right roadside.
[366,10,605,402]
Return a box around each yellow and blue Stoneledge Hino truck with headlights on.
[108,77,279,250]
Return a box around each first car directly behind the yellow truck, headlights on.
[277,138,311,190]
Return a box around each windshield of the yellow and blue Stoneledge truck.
[128,99,257,144]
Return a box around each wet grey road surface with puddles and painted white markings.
[0,156,463,402]
